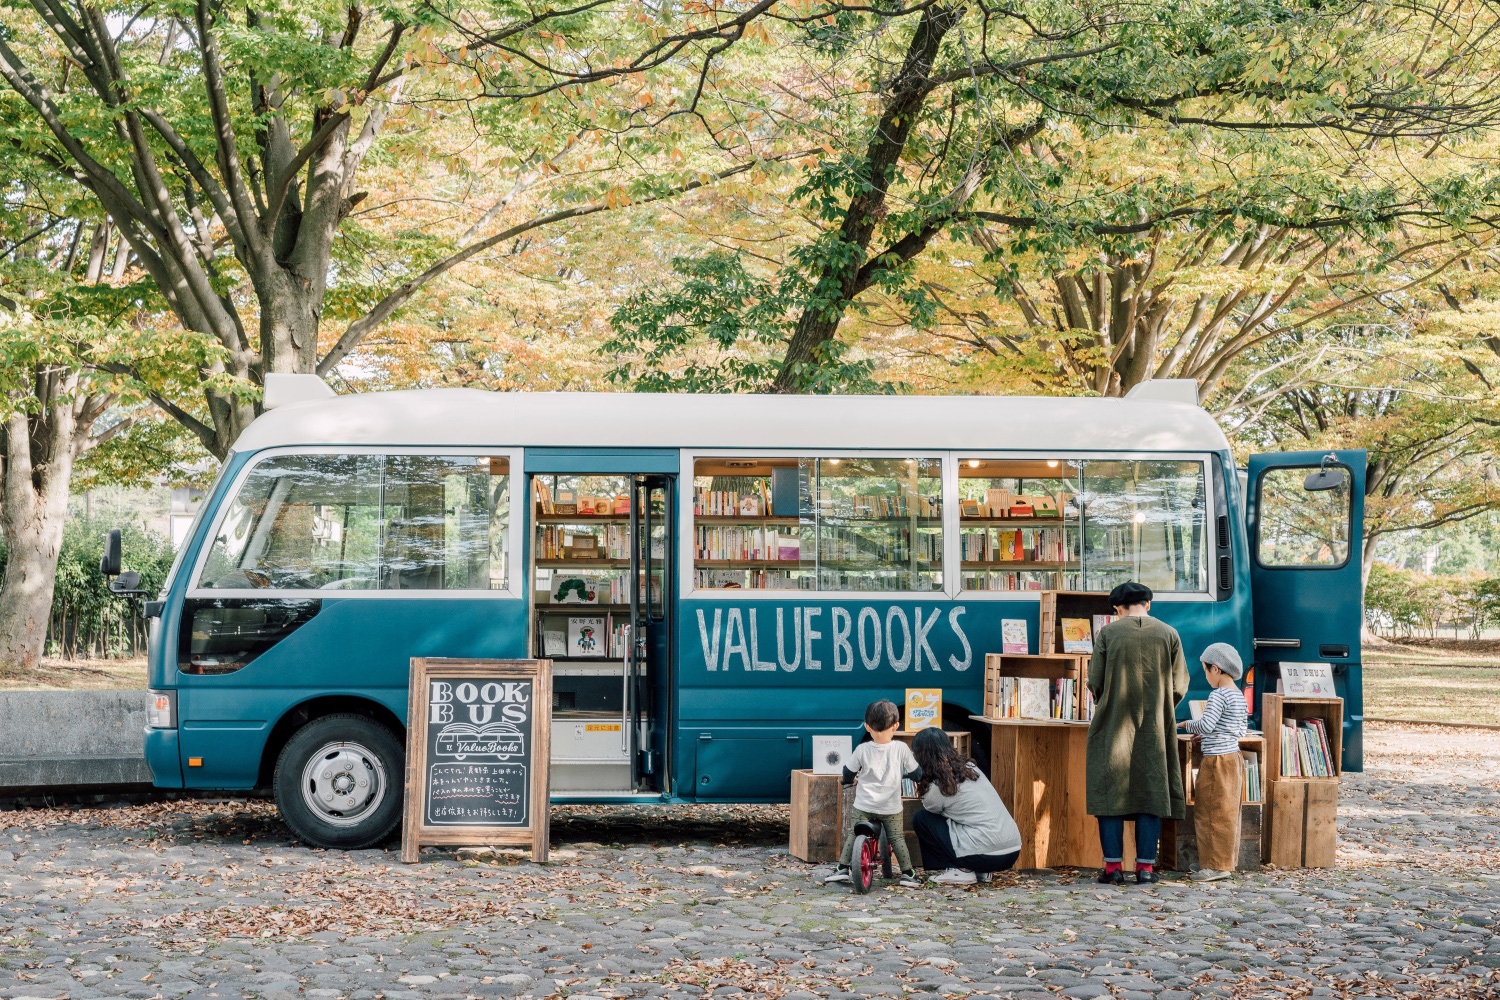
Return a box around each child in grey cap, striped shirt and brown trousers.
[1179,642,1247,882]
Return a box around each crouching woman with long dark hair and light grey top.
[912,729,1022,886]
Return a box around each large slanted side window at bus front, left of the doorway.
[197,454,510,591]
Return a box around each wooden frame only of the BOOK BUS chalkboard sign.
[401,657,552,864]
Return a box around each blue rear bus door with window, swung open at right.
[1245,451,1365,771]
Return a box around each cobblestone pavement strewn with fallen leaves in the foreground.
[0,726,1500,1000]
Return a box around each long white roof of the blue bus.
[234,388,1229,453]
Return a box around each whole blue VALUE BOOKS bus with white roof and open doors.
[113,375,1365,849]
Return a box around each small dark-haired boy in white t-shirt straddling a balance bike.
[824,699,923,888]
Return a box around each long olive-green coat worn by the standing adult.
[1088,615,1188,820]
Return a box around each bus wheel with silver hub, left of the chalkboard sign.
[275,714,405,850]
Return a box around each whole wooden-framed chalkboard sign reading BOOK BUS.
[401,657,552,862]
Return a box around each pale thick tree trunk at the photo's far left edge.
[0,405,75,673]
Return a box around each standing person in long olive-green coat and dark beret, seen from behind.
[1088,583,1188,885]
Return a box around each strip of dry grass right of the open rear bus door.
[1364,665,1500,726]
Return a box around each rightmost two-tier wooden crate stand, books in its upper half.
[1260,694,1344,868]
